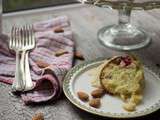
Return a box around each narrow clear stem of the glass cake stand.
[118,5,132,25]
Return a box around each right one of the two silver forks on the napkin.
[21,25,35,91]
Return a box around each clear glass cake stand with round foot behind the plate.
[90,0,160,50]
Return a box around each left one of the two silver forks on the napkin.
[9,27,24,91]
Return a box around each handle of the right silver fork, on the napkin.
[22,51,34,91]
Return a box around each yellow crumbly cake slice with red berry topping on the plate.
[99,56,144,111]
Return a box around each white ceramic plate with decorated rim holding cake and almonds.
[63,60,160,118]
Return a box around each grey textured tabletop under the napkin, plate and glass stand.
[0,4,160,120]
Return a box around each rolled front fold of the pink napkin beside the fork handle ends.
[21,74,61,104]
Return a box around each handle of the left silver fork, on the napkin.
[12,51,24,91]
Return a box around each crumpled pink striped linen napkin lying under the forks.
[0,16,75,104]
